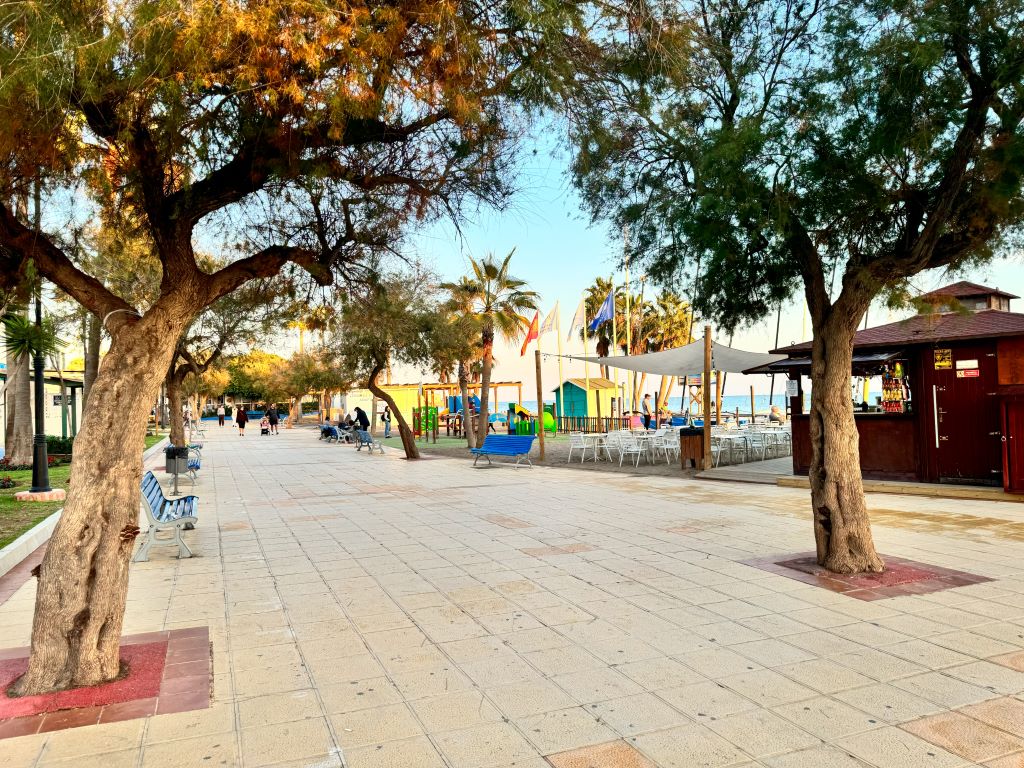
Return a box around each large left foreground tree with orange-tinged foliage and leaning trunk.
[0,0,581,694]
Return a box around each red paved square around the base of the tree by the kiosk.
[744,553,992,600]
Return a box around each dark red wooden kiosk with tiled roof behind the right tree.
[749,282,1024,494]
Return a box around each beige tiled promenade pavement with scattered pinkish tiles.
[0,427,1024,768]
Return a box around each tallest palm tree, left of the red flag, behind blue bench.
[442,249,540,442]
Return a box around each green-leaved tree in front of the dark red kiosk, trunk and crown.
[571,0,1024,572]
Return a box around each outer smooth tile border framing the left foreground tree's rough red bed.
[0,627,212,739]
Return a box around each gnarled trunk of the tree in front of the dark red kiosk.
[810,309,884,573]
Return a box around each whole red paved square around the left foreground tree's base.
[0,627,212,738]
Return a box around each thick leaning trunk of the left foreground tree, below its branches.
[13,308,184,695]
